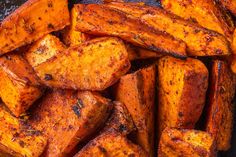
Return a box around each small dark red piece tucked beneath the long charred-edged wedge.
[126,44,163,61]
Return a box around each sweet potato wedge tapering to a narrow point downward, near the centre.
[115,65,156,156]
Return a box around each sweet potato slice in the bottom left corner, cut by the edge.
[0,103,47,157]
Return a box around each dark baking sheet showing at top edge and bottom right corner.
[0,0,236,157]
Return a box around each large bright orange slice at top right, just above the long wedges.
[161,0,234,41]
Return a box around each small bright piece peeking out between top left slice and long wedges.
[62,8,89,46]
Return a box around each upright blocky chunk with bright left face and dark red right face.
[158,56,208,137]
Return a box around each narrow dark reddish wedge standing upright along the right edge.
[206,60,235,151]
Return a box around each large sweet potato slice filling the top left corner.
[0,0,70,55]
